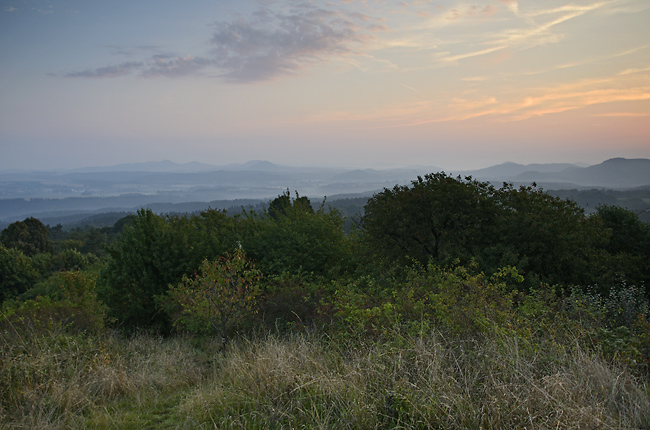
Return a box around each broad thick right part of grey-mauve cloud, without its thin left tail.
[205,6,372,82]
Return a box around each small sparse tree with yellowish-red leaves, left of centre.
[163,249,260,344]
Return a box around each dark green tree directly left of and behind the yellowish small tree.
[100,209,236,330]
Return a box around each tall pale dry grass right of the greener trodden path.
[181,334,650,429]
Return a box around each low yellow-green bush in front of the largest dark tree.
[325,264,522,336]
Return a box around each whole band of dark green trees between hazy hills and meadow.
[0,172,650,352]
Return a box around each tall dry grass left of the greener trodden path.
[0,320,207,429]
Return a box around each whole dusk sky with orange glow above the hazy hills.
[0,0,650,170]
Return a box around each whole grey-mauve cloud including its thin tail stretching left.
[65,2,380,83]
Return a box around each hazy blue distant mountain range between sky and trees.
[0,158,650,223]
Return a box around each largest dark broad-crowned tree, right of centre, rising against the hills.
[361,172,603,286]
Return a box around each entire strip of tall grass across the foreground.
[0,324,650,429]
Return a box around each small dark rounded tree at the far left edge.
[0,217,54,257]
